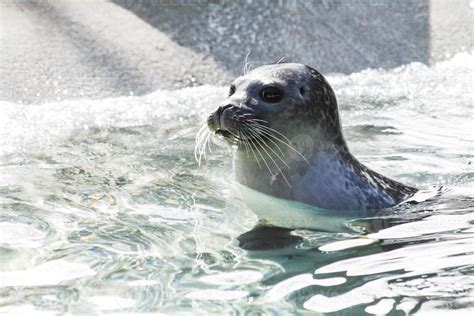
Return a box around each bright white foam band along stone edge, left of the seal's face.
[0,86,223,157]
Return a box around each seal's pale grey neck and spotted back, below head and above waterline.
[234,147,412,210]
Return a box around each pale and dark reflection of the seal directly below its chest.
[232,185,373,278]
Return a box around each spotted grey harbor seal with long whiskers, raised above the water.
[202,63,417,210]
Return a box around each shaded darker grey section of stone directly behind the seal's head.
[115,0,430,73]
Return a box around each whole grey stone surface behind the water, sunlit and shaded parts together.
[0,0,474,103]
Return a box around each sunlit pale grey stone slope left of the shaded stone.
[0,0,230,103]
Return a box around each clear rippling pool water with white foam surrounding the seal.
[0,54,474,315]
